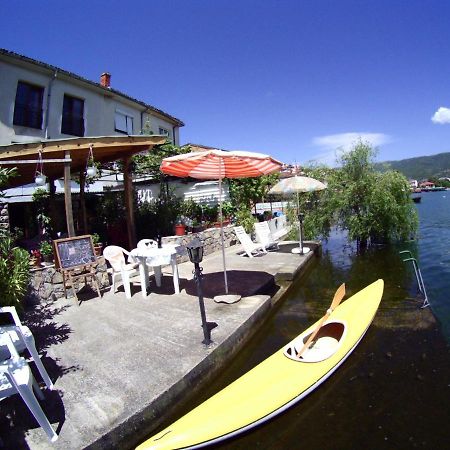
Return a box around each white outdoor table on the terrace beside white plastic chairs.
[131,244,180,298]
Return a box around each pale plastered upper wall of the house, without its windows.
[0,55,179,145]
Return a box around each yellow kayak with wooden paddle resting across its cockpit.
[137,280,384,450]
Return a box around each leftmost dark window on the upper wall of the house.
[13,81,44,129]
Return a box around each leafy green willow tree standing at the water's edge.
[307,141,418,249]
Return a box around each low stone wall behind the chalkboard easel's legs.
[25,257,110,304]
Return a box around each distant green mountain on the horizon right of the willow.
[376,152,450,180]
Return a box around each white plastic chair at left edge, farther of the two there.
[0,306,53,390]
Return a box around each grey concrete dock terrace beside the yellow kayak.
[0,241,318,450]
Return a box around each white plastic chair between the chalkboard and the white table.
[103,245,139,298]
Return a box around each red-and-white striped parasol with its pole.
[161,149,282,300]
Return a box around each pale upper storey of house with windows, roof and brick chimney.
[0,49,184,145]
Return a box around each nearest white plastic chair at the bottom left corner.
[0,332,58,442]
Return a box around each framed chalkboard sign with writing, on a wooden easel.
[53,234,97,269]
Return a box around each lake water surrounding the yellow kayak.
[146,191,450,450]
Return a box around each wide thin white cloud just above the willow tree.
[313,132,391,165]
